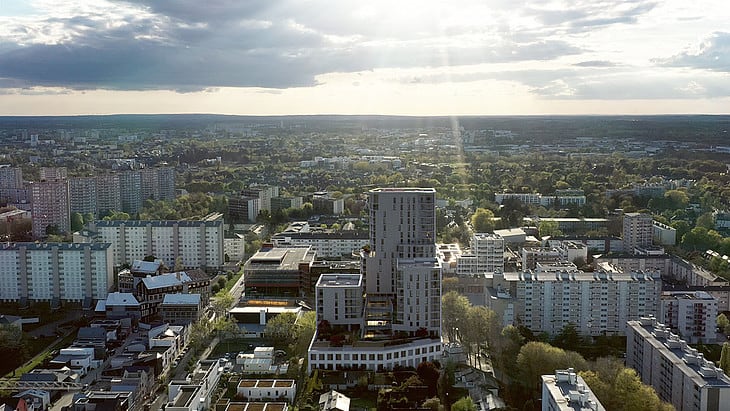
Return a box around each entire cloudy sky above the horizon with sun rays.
[0,0,730,115]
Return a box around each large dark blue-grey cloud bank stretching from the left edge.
[0,0,582,92]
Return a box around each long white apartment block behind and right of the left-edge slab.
[80,216,225,269]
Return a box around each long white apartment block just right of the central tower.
[486,263,662,335]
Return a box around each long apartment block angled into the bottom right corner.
[626,317,730,411]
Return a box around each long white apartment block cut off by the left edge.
[0,243,114,306]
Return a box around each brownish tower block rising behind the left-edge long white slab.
[31,180,71,238]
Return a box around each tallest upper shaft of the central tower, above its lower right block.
[363,188,436,295]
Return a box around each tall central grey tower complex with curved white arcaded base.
[308,188,443,372]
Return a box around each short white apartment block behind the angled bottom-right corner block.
[658,291,718,344]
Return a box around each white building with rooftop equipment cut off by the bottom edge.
[541,368,606,411]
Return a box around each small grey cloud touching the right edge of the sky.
[655,32,730,71]
